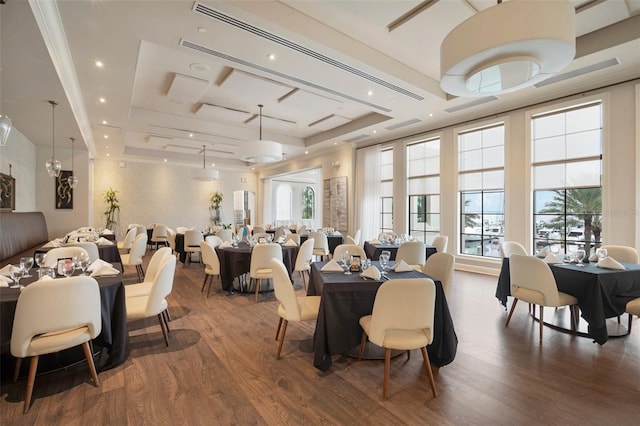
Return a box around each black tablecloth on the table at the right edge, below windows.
[496,258,640,345]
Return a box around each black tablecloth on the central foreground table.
[307,262,458,370]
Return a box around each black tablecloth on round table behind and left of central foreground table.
[216,243,300,291]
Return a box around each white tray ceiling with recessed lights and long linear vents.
[0,0,640,168]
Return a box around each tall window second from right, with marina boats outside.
[458,123,504,257]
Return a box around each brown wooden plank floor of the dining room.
[0,251,640,425]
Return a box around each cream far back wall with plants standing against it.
[92,160,257,239]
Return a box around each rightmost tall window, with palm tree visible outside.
[531,102,602,255]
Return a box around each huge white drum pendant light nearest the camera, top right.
[440,0,576,97]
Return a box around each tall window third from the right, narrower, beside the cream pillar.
[407,139,440,244]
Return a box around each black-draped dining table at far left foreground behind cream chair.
[0,263,129,378]
